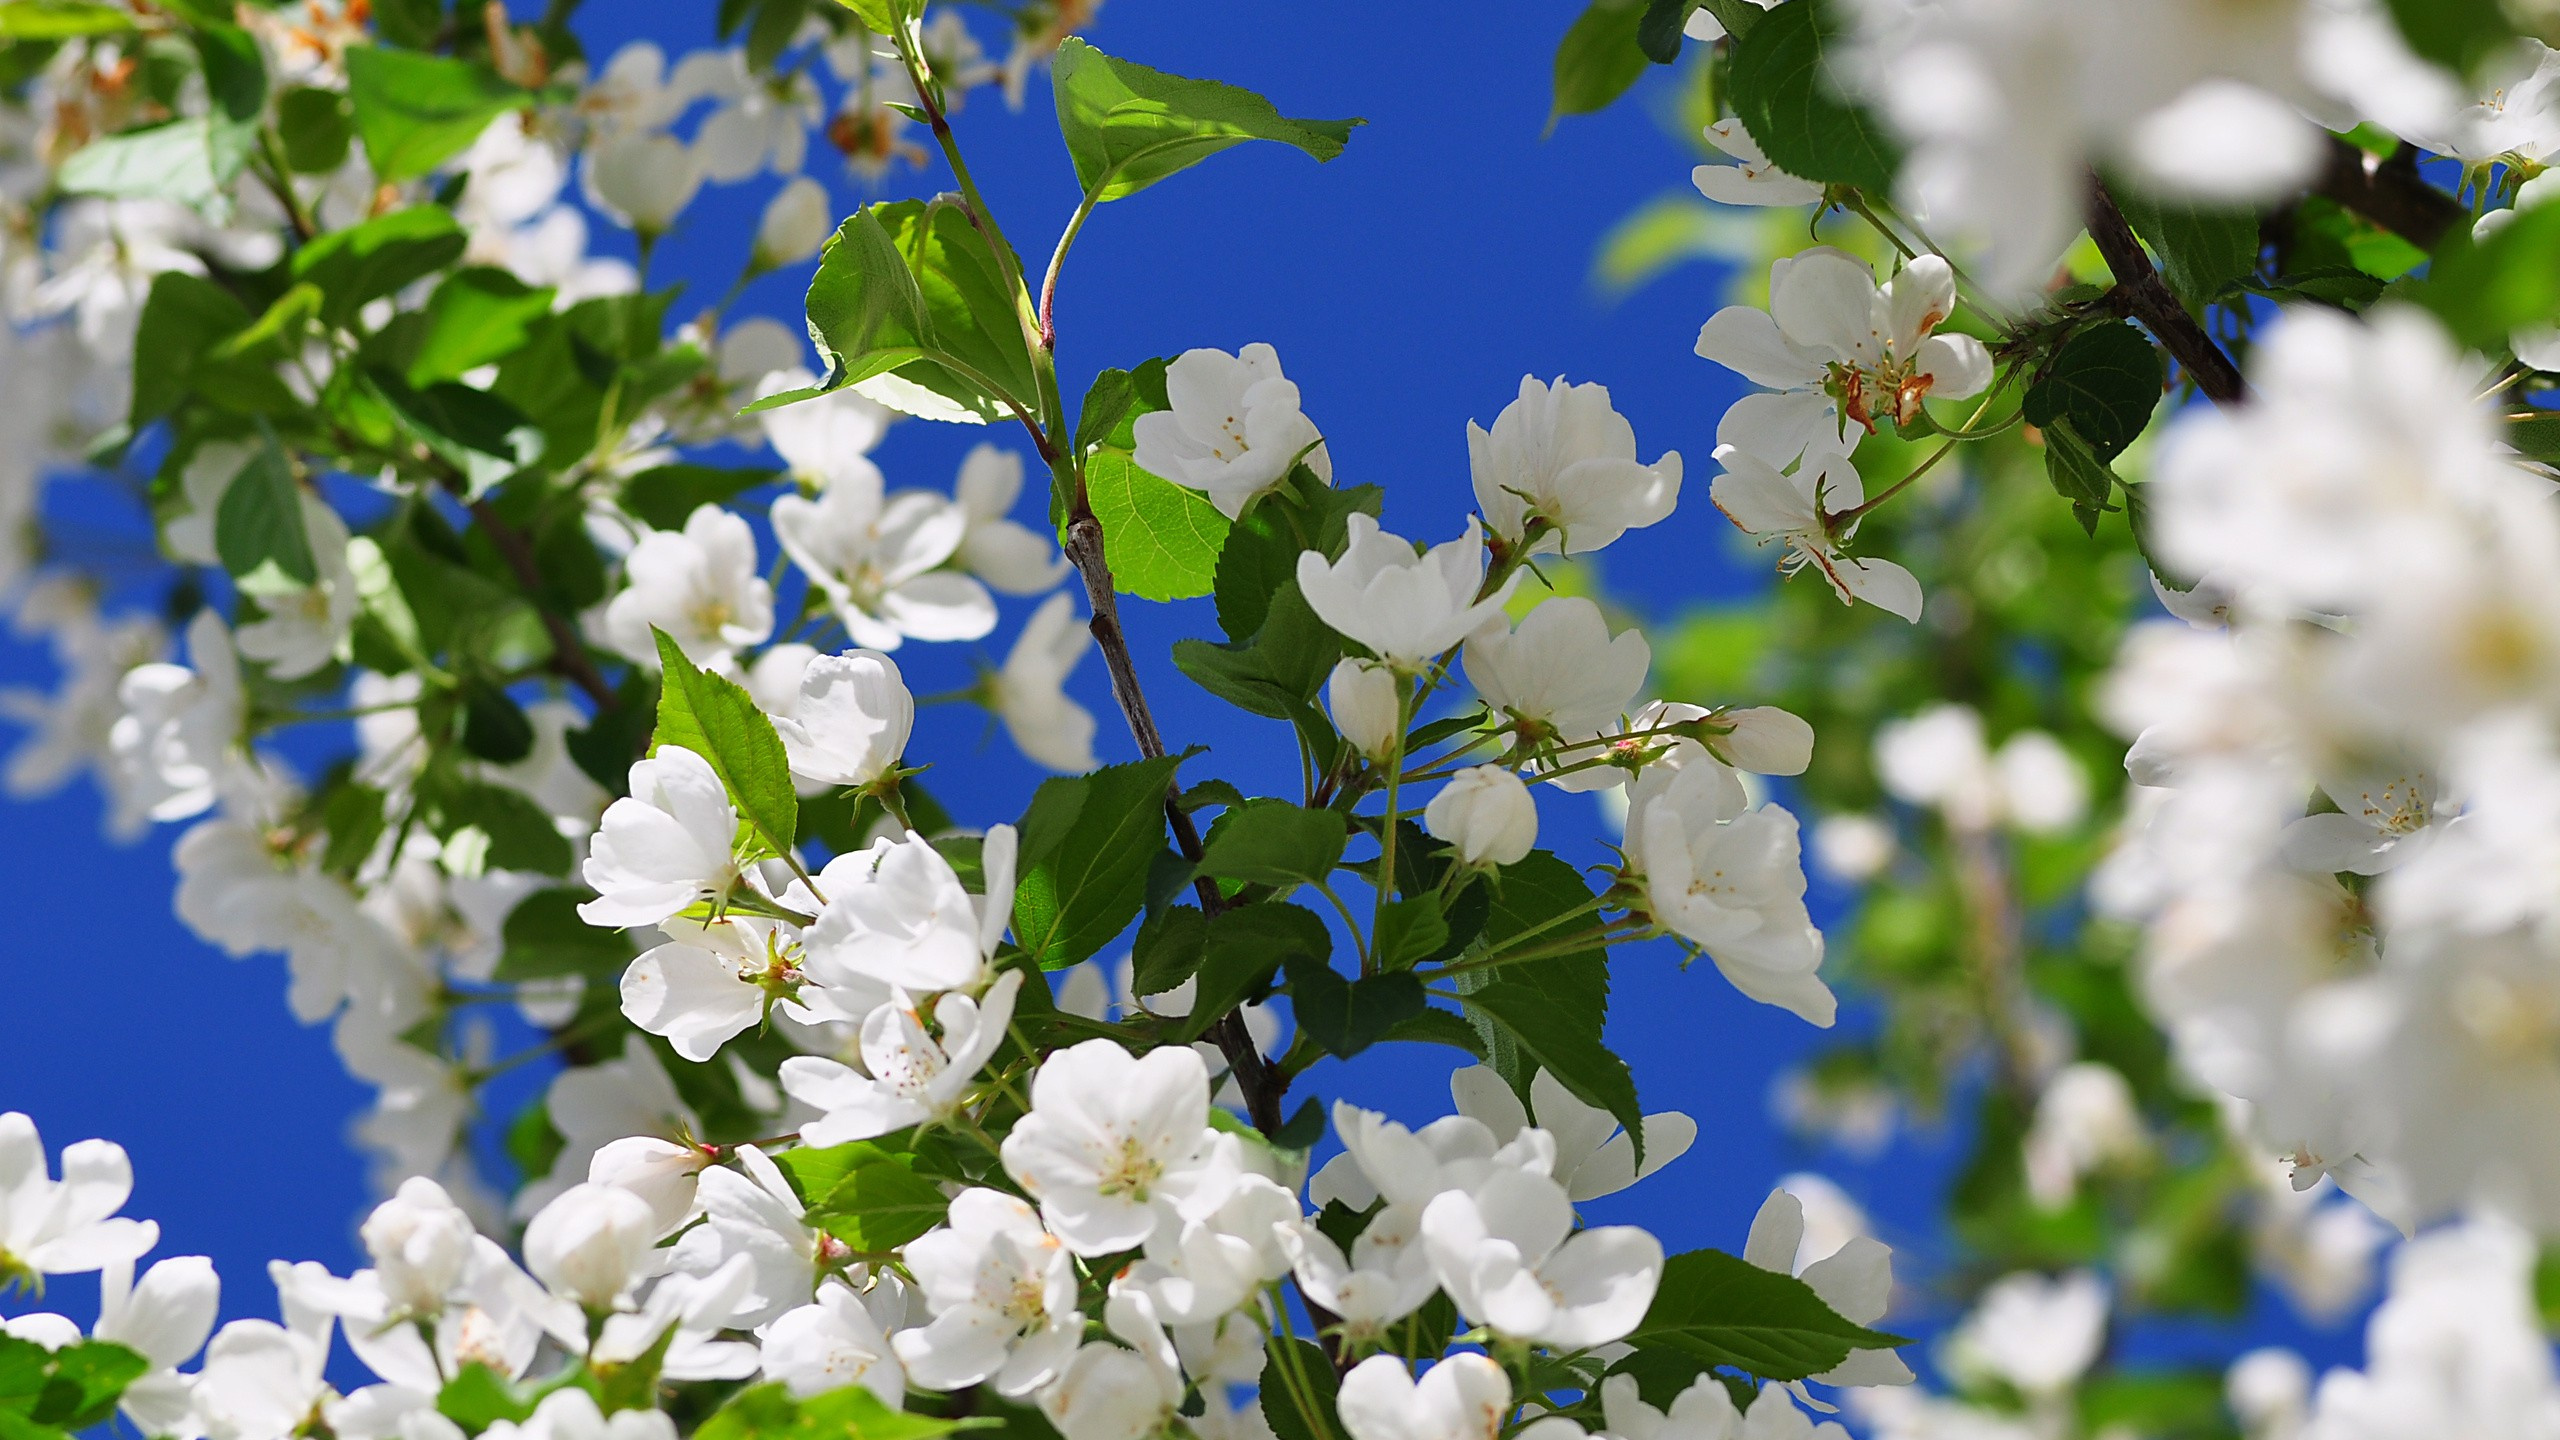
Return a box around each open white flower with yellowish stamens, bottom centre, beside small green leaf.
[891,1189,1085,1399]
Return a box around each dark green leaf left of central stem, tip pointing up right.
[1014,756,1180,971]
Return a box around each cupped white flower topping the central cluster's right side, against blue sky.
[1467,377,1679,556]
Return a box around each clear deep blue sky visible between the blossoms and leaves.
[0,0,2355,1393]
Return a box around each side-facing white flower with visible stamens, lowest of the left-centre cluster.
[781,971,1021,1145]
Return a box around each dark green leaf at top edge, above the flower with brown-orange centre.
[1733,0,1902,192]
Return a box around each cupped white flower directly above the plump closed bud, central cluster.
[1298,510,1521,671]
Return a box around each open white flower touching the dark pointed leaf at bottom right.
[1423,1171,1661,1350]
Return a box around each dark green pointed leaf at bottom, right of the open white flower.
[1628,1250,1910,1381]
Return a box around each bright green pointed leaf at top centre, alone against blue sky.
[1050,36,1364,202]
